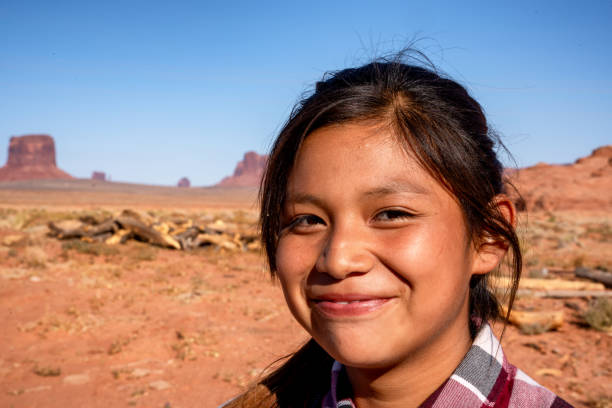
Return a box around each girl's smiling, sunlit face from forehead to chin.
[276,124,490,368]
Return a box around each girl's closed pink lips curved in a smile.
[312,294,392,317]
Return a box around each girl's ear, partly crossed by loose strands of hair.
[472,194,516,275]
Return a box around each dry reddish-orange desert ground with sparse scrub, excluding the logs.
[0,180,612,408]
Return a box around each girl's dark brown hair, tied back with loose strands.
[227,53,521,407]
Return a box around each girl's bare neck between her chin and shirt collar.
[346,327,472,408]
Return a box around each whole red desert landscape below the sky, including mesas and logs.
[0,138,612,408]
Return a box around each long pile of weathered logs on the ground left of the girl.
[48,210,261,251]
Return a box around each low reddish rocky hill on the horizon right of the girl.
[508,145,612,211]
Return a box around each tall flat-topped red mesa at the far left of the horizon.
[0,135,73,181]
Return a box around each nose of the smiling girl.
[316,223,375,279]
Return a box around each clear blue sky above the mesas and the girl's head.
[0,0,612,185]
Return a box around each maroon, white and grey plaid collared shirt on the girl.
[321,324,572,408]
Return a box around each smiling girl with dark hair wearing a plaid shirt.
[227,55,569,408]
